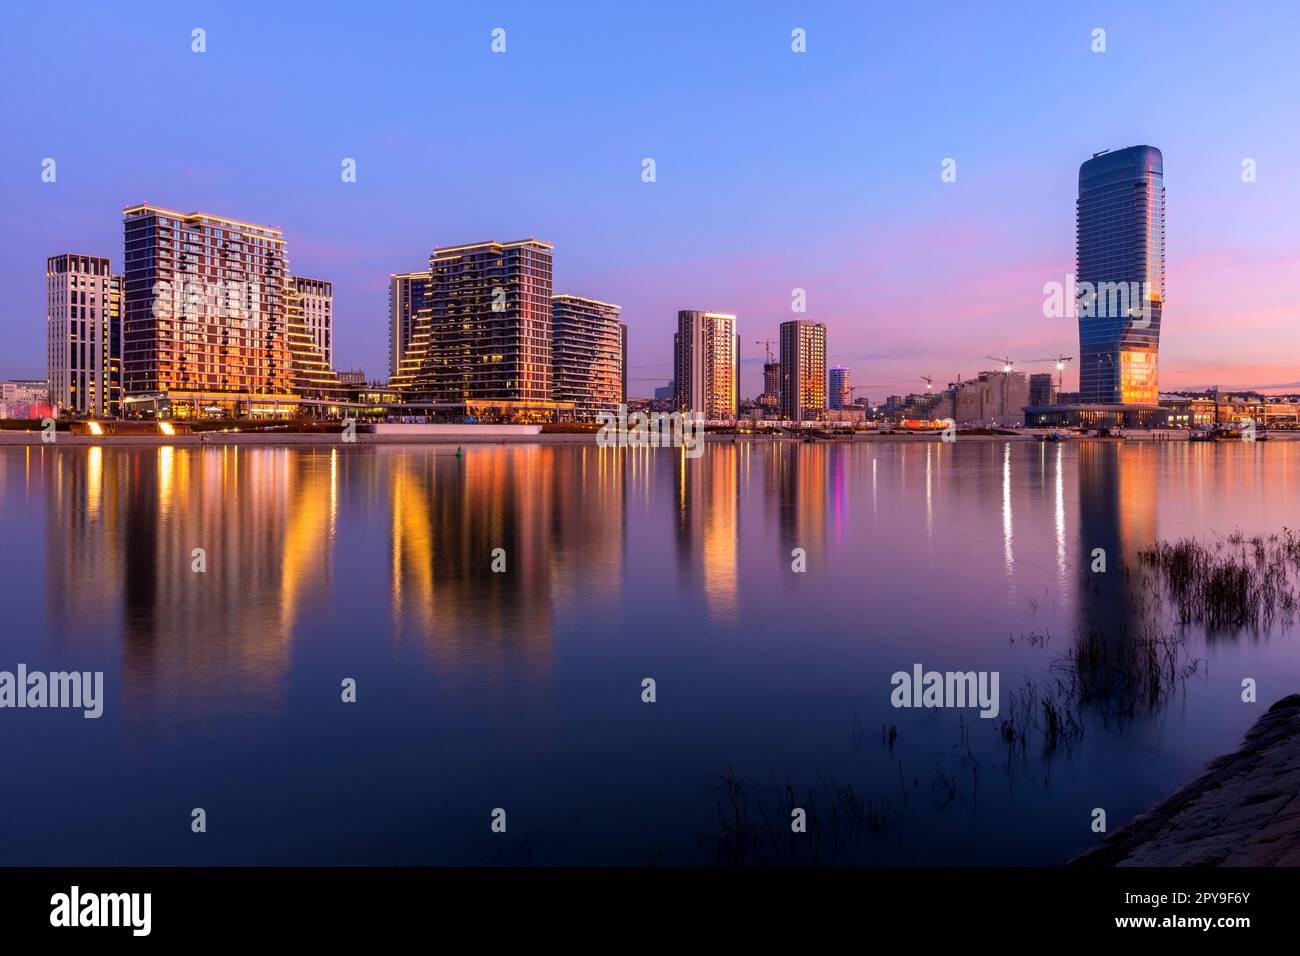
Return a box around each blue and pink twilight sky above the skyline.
[0,0,1300,401]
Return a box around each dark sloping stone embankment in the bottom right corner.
[1071,695,1300,866]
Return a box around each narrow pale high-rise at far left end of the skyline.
[46,254,122,416]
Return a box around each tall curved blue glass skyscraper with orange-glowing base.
[1075,146,1165,405]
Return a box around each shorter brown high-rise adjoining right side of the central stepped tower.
[551,295,627,421]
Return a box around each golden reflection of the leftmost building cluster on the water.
[47,446,338,698]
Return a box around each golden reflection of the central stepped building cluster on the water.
[374,445,628,662]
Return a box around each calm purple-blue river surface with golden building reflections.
[0,441,1300,865]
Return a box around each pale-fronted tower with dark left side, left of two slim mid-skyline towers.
[672,310,740,421]
